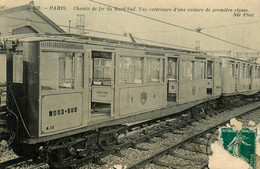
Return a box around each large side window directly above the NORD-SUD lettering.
[40,52,78,90]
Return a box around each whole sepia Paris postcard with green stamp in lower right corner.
[0,0,260,169]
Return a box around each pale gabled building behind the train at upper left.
[0,2,66,83]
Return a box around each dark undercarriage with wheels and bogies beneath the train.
[0,93,260,168]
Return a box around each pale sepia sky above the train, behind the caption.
[0,0,260,52]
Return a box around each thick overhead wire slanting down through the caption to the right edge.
[89,0,259,52]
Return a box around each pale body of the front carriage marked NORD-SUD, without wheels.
[1,33,220,143]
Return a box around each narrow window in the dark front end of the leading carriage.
[13,52,23,83]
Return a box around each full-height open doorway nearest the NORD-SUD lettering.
[91,51,114,116]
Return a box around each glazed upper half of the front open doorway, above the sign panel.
[92,52,112,85]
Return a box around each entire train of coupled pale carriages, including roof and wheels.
[0,35,260,165]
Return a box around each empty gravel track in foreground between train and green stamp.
[79,102,260,168]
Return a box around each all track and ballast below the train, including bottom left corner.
[0,102,260,168]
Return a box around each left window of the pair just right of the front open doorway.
[119,56,143,84]
